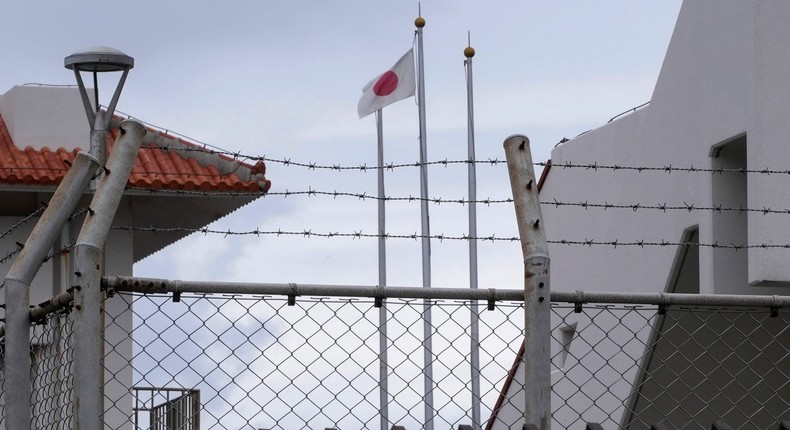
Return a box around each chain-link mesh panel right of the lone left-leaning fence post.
[552,305,790,429]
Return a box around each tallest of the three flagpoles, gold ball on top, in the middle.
[414,12,434,430]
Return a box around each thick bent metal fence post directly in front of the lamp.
[74,121,145,430]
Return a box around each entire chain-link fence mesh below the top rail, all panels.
[0,289,790,430]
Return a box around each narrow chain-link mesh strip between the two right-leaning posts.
[29,311,74,430]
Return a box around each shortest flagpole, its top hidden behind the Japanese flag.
[376,109,389,430]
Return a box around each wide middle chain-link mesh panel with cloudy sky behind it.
[106,294,523,429]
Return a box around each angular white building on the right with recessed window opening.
[489,0,790,429]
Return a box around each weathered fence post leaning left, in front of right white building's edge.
[504,135,551,430]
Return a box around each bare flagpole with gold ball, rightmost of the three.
[464,37,482,430]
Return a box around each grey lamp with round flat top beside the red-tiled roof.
[63,46,134,170]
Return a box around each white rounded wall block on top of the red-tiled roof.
[0,85,93,150]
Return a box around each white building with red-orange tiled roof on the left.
[0,86,271,429]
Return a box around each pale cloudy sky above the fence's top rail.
[0,0,680,288]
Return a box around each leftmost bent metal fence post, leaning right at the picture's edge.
[4,152,99,429]
